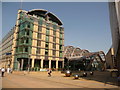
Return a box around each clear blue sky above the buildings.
[2,2,112,53]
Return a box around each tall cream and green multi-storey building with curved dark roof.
[0,9,64,70]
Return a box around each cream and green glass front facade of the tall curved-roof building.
[11,11,64,69]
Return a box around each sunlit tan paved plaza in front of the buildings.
[2,72,118,90]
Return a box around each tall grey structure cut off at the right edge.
[109,0,120,75]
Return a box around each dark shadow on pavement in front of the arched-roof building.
[72,71,120,86]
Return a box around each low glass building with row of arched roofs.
[64,46,106,71]
